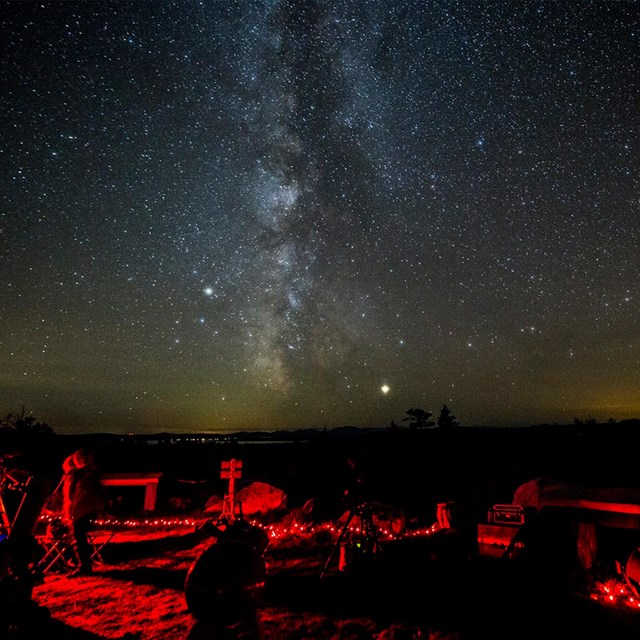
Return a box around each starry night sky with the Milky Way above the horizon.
[0,0,640,434]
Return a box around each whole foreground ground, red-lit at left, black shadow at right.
[27,524,640,640]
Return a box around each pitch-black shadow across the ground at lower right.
[264,540,640,640]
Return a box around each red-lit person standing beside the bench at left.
[62,449,105,575]
